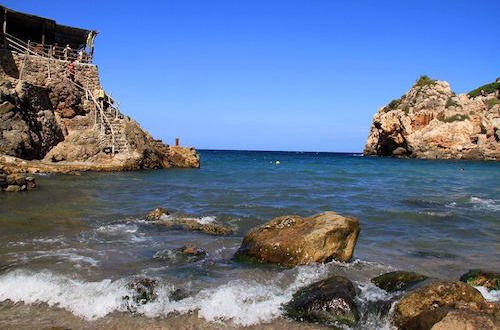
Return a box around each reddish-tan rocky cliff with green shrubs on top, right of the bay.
[363,76,500,160]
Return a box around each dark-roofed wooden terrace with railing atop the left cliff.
[0,5,97,63]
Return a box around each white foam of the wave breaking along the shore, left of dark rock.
[0,265,327,326]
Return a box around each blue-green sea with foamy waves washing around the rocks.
[0,150,500,329]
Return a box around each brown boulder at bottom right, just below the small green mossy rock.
[392,282,486,329]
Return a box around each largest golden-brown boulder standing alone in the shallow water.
[236,212,359,267]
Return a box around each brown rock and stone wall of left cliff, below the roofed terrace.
[0,50,199,172]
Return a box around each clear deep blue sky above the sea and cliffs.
[2,0,500,152]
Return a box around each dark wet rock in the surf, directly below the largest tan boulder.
[283,276,359,326]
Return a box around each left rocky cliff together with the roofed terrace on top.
[0,5,200,174]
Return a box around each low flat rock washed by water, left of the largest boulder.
[146,207,233,235]
